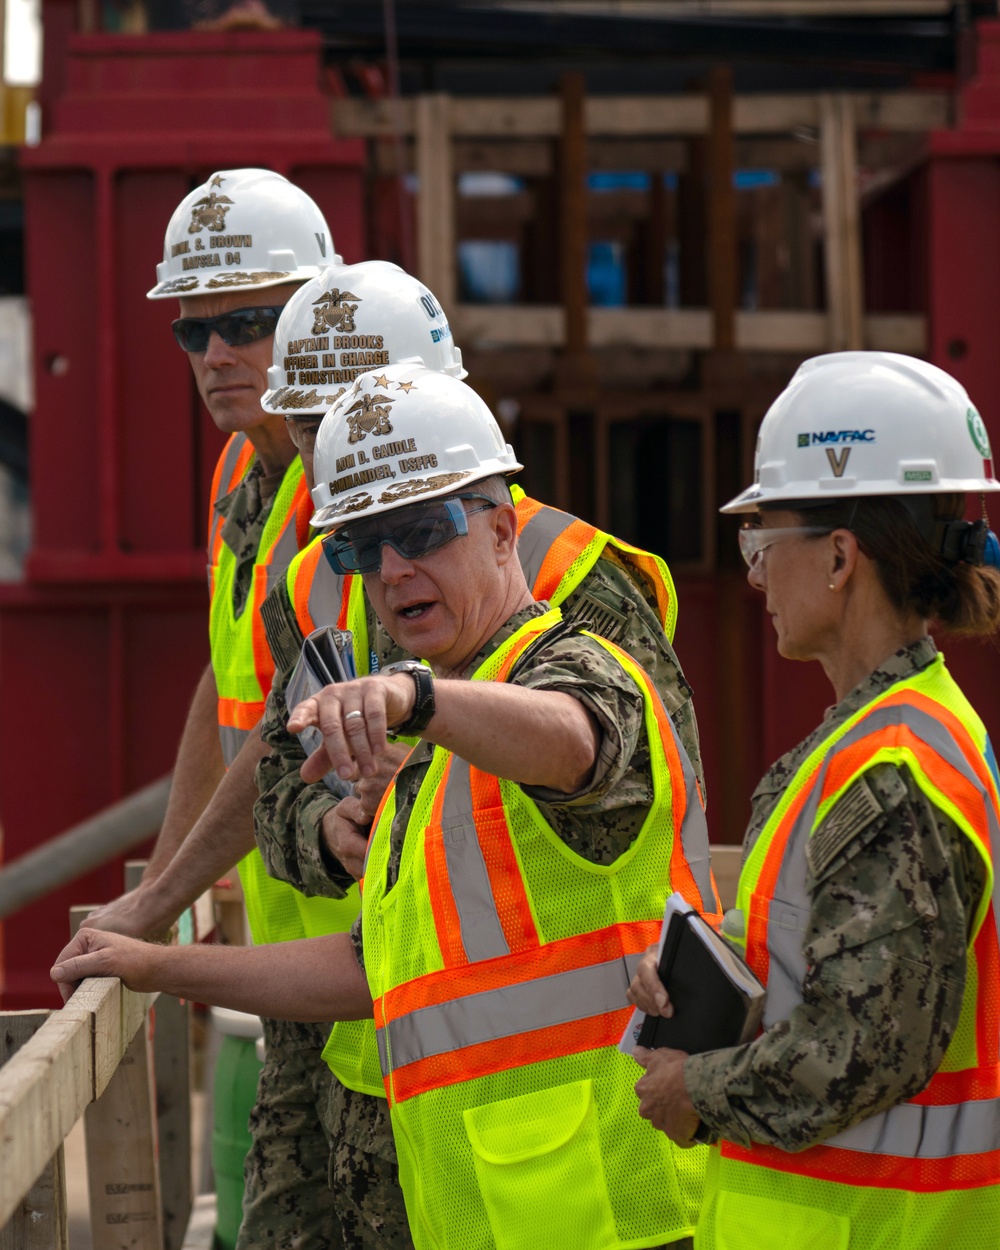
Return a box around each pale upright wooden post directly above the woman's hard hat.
[820,95,865,351]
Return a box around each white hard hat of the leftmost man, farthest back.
[146,169,340,300]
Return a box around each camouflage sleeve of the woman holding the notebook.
[684,764,985,1150]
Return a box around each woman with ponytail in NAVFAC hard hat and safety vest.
[630,353,1000,1250]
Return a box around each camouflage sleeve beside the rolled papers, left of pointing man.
[254,678,354,899]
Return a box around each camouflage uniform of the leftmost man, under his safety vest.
[215,460,344,1250]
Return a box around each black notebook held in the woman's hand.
[621,894,764,1055]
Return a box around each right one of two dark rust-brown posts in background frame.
[708,65,738,351]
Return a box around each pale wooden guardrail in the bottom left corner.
[0,864,202,1250]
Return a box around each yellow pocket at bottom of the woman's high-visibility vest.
[713,1190,851,1250]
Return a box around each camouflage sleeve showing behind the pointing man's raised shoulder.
[561,546,706,798]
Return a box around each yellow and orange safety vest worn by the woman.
[696,656,1000,1250]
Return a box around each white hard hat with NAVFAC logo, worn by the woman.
[721,351,1000,513]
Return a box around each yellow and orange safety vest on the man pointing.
[363,609,718,1250]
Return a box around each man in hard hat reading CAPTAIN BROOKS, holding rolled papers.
[81,261,701,1245]
